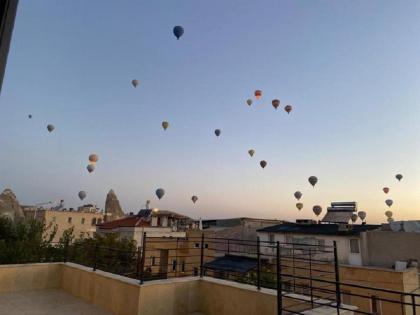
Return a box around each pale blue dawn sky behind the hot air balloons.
[0,0,420,222]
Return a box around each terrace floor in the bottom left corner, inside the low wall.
[0,289,111,315]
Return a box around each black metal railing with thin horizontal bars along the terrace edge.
[1,233,420,315]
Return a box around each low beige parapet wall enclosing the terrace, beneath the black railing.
[0,263,356,315]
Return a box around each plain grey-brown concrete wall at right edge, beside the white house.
[361,231,420,268]
